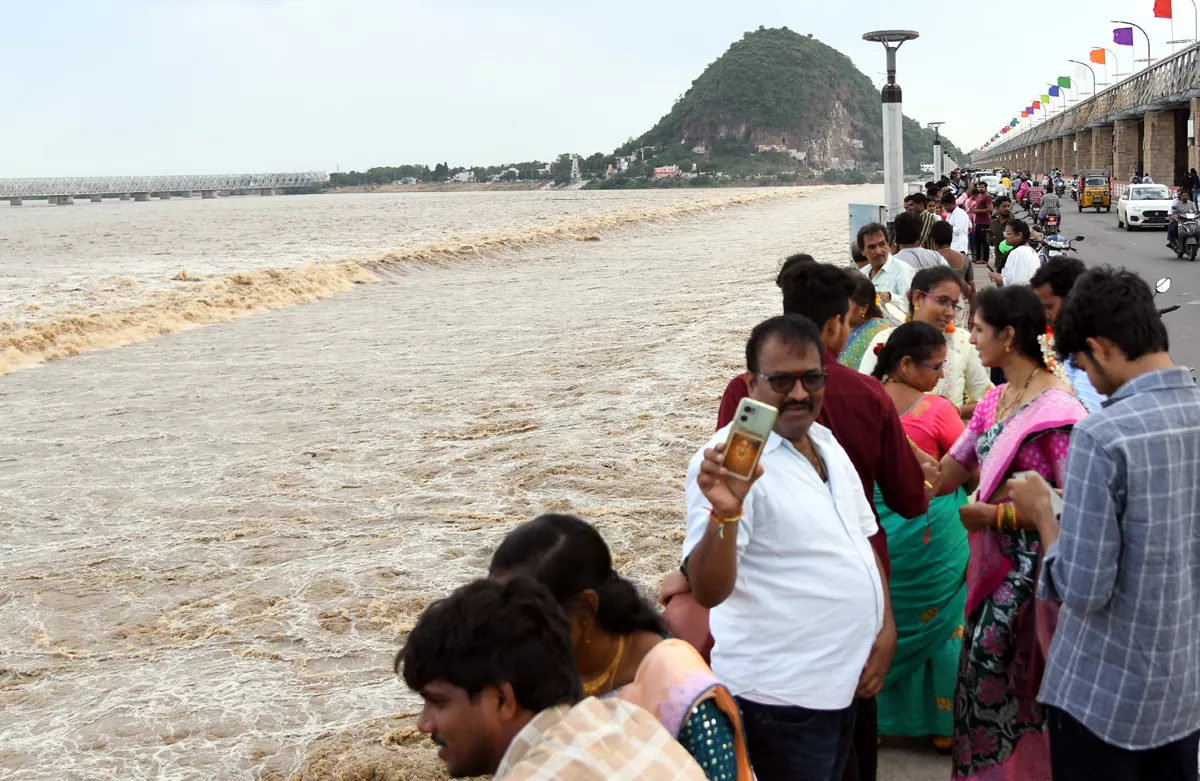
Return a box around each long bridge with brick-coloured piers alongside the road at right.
[972,44,1200,185]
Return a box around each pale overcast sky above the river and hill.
[0,0,1193,179]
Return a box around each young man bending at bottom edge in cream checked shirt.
[396,578,706,781]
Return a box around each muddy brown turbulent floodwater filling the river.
[0,187,880,780]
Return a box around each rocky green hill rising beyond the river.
[618,28,966,172]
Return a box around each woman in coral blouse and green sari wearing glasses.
[872,323,970,752]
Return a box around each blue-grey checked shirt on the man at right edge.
[1038,367,1200,750]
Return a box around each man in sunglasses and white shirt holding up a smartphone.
[684,314,895,781]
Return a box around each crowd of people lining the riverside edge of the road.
[396,175,1200,781]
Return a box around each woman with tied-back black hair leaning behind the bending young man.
[488,515,754,781]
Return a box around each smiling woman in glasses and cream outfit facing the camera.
[858,266,992,420]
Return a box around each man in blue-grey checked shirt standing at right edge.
[1009,268,1200,781]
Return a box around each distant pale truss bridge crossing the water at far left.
[0,170,329,206]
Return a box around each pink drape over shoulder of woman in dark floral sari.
[967,390,1087,615]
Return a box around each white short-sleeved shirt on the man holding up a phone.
[683,423,883,710]
